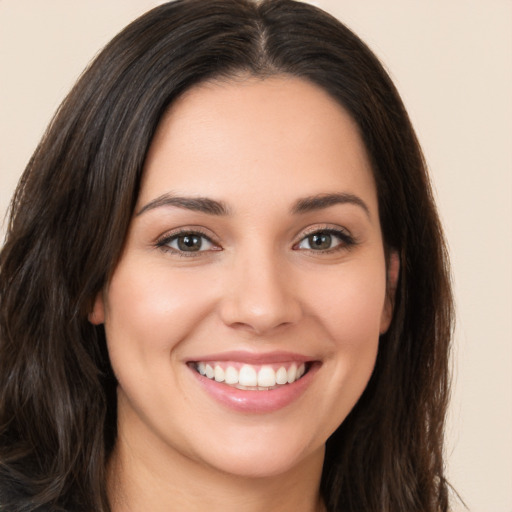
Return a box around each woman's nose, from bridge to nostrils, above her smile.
[220,249,302,335]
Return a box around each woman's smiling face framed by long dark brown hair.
[90,77,397,476]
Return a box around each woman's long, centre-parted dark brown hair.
[0,0,452,512]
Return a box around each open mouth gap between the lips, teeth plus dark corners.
[189,361,311,391]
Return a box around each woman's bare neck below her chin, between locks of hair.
[108,430,325,512]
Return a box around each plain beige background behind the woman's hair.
[0,0,512,512]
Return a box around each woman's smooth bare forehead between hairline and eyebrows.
[139,76,376,212]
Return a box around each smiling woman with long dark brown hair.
[0,0,452,511]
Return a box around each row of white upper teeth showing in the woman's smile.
[196,362,306,388]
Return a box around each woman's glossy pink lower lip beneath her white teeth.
[191,364,320,413]
